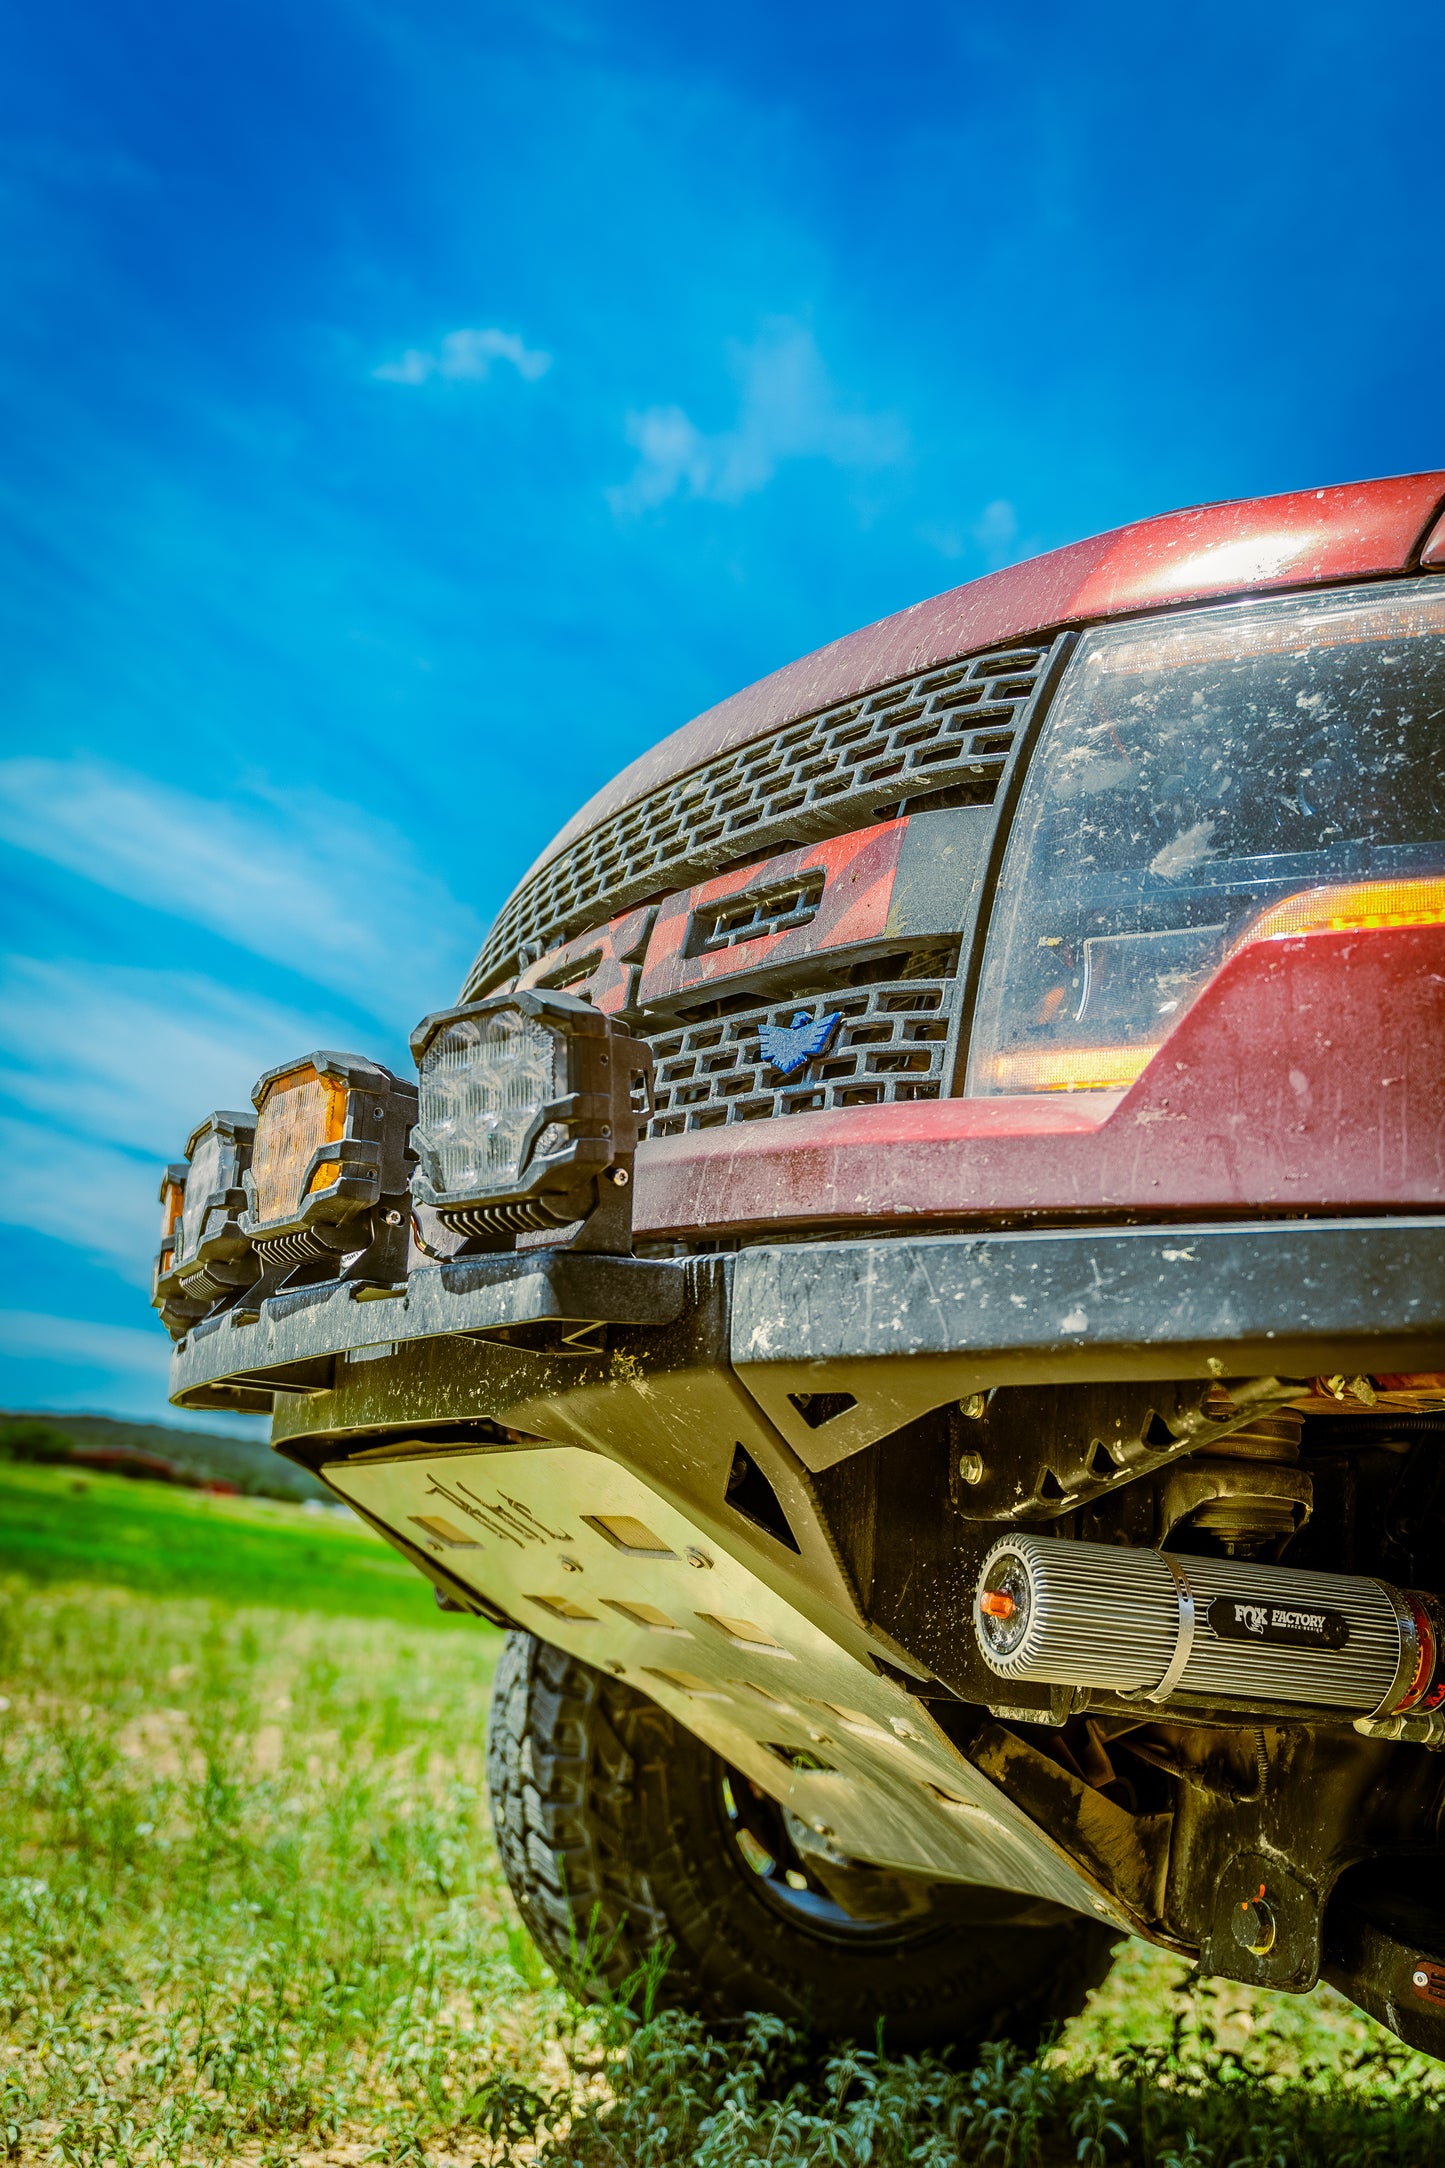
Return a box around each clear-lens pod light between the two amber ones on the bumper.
[152,1112,256,1333]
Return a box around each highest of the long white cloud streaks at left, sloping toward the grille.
[0,759,479,1030]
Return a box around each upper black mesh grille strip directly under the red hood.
[464,644,1051,999]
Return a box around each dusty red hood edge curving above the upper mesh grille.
[522,473,1445,880]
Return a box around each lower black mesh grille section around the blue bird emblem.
[641,947,958,1136]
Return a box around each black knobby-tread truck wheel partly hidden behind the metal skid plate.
[487,1633,1118,2053]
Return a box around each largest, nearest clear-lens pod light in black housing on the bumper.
[412,993,652,1249]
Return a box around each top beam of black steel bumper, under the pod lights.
[171,1218,1445,1470]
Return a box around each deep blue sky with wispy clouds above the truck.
[0,0,1445,1439]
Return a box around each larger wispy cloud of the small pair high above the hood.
[607,323,908,516]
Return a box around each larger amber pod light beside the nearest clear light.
[243,1054,416,1283]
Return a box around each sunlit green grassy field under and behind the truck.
[0,1468,1445,2168]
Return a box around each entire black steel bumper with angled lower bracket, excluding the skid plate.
[161,1216,1445,1706]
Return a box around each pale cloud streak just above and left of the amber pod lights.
[0,956,355,1188]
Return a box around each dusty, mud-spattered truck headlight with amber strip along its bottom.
[968,581,1445,1095]
